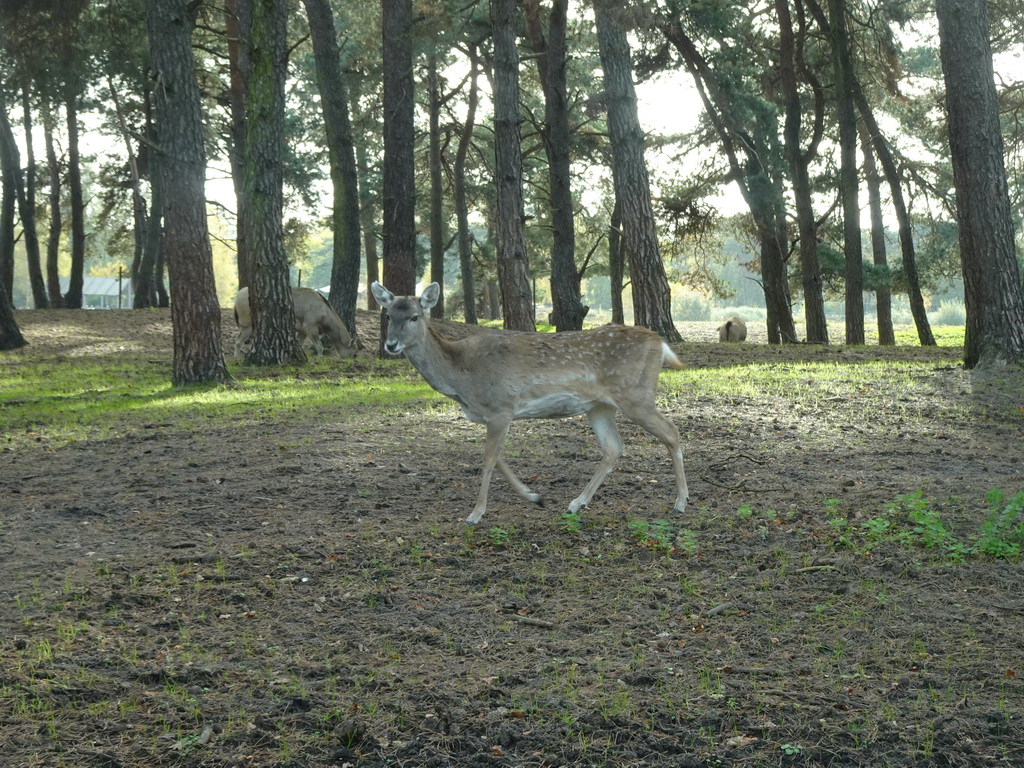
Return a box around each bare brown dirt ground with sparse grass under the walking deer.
[0,310,1024,768]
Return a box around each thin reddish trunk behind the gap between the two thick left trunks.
[224,0,253,289]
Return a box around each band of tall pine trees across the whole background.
[0,0,1024,370]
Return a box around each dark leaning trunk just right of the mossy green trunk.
[305,0,369,339]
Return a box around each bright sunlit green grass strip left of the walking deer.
[0,357,440,447]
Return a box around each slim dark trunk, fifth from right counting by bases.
[775,0,828,344]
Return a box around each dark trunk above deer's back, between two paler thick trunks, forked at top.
[523,0,589,331]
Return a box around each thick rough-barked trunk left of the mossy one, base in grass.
[148,0,231,385]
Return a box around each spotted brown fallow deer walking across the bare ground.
[371,283,687,523]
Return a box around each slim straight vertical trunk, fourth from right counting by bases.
[828,0,864,344]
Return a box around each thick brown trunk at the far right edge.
[935,0,1024,368]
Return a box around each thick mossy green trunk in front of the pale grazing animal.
[245,0,306,366]
